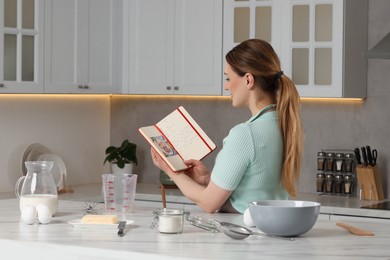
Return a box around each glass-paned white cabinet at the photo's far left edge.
[0,0,44,93]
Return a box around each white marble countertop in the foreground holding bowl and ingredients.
[0,199,390,260]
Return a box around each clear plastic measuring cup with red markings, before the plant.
[102,173,138,213]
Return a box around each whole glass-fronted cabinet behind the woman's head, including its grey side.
[224,0,368,98]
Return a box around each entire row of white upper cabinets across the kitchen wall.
[0,0,368,98]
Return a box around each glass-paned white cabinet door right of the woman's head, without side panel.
[283,0,343,97]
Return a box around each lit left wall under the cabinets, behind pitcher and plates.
[0,94,110,192]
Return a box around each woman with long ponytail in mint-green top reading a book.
[151,39,302,213]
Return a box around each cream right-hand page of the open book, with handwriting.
[156,106,215,160]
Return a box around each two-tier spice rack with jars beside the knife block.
[316,148,357,197]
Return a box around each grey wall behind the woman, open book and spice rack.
[111,0,390,197]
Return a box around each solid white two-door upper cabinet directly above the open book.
[123,0,222,95]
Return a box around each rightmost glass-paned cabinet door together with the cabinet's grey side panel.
[281,0,368,98]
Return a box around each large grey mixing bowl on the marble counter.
[249,200,320,237]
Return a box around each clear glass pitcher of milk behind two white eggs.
[15,161,58,216]
